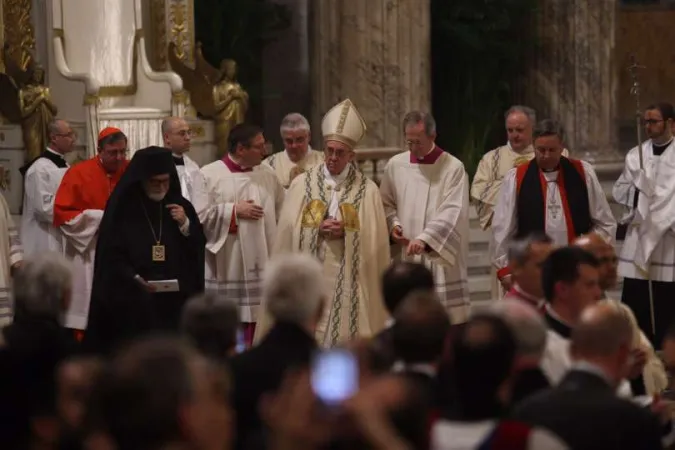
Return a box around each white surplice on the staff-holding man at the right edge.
[612,140,675,282]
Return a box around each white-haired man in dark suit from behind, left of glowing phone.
[230,254,328,449]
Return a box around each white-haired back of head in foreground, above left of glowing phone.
[263,253,326,325]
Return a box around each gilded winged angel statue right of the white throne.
[168,42,248,157]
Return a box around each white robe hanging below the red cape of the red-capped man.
[60,209,103,330]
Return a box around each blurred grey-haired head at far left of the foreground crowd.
[13,252,73,319]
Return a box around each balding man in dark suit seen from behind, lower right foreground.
[514,304,662,450]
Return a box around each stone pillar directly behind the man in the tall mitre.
[310,0,431,148]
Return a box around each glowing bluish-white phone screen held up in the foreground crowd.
[311,349,359,406]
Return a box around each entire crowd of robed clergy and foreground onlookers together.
[0,94,675,450]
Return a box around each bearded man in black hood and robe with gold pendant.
[84,147,205,354]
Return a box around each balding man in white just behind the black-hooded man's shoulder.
[162,117,207,214]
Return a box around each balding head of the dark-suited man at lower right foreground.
[570,303,633,387]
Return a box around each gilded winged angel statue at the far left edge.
[0,46,57,161]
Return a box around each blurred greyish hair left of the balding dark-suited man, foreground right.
[481,298,547,358]
